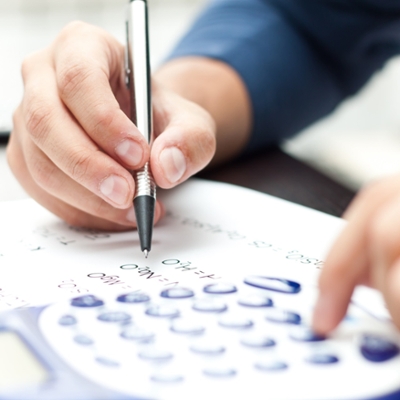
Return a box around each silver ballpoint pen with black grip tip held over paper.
[125,0,156,258]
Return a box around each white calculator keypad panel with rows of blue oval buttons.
[40,276,399,399]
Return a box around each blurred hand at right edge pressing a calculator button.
[313,175,400,334]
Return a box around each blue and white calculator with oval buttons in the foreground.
[0,275,400,400]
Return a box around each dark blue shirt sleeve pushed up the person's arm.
[164,0,400,155]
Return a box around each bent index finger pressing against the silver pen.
[53,22,149,169]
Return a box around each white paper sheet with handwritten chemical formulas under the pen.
[0,179,344,310]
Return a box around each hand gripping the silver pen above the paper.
[7,22,215,230]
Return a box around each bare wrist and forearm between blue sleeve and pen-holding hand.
[154,57,252,164]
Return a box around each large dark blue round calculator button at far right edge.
[360,335,399,362]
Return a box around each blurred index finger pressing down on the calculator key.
[313,177,400,334]
